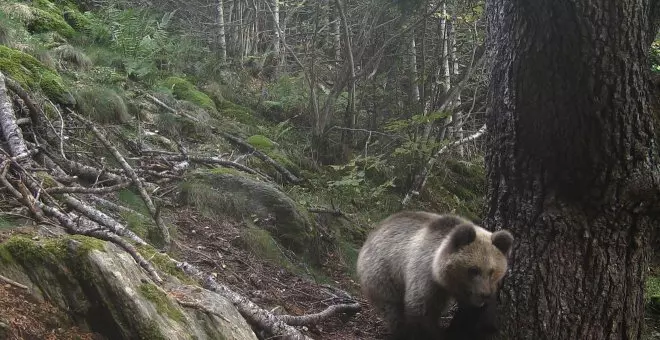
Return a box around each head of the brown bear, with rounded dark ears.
[432,223,513,307]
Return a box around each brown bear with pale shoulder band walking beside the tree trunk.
[357,211,513,340]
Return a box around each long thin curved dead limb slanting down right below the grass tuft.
[69,110,172,248]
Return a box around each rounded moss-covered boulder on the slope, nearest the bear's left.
[181,171,317,259]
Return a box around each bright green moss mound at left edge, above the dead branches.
[0,45,75,105]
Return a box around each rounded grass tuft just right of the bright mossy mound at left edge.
[75,87,131,124]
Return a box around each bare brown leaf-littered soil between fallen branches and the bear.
[170,209,386,340]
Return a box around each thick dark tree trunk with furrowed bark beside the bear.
[485,0,658,340]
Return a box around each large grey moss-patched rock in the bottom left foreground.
[0,236,256,340]
